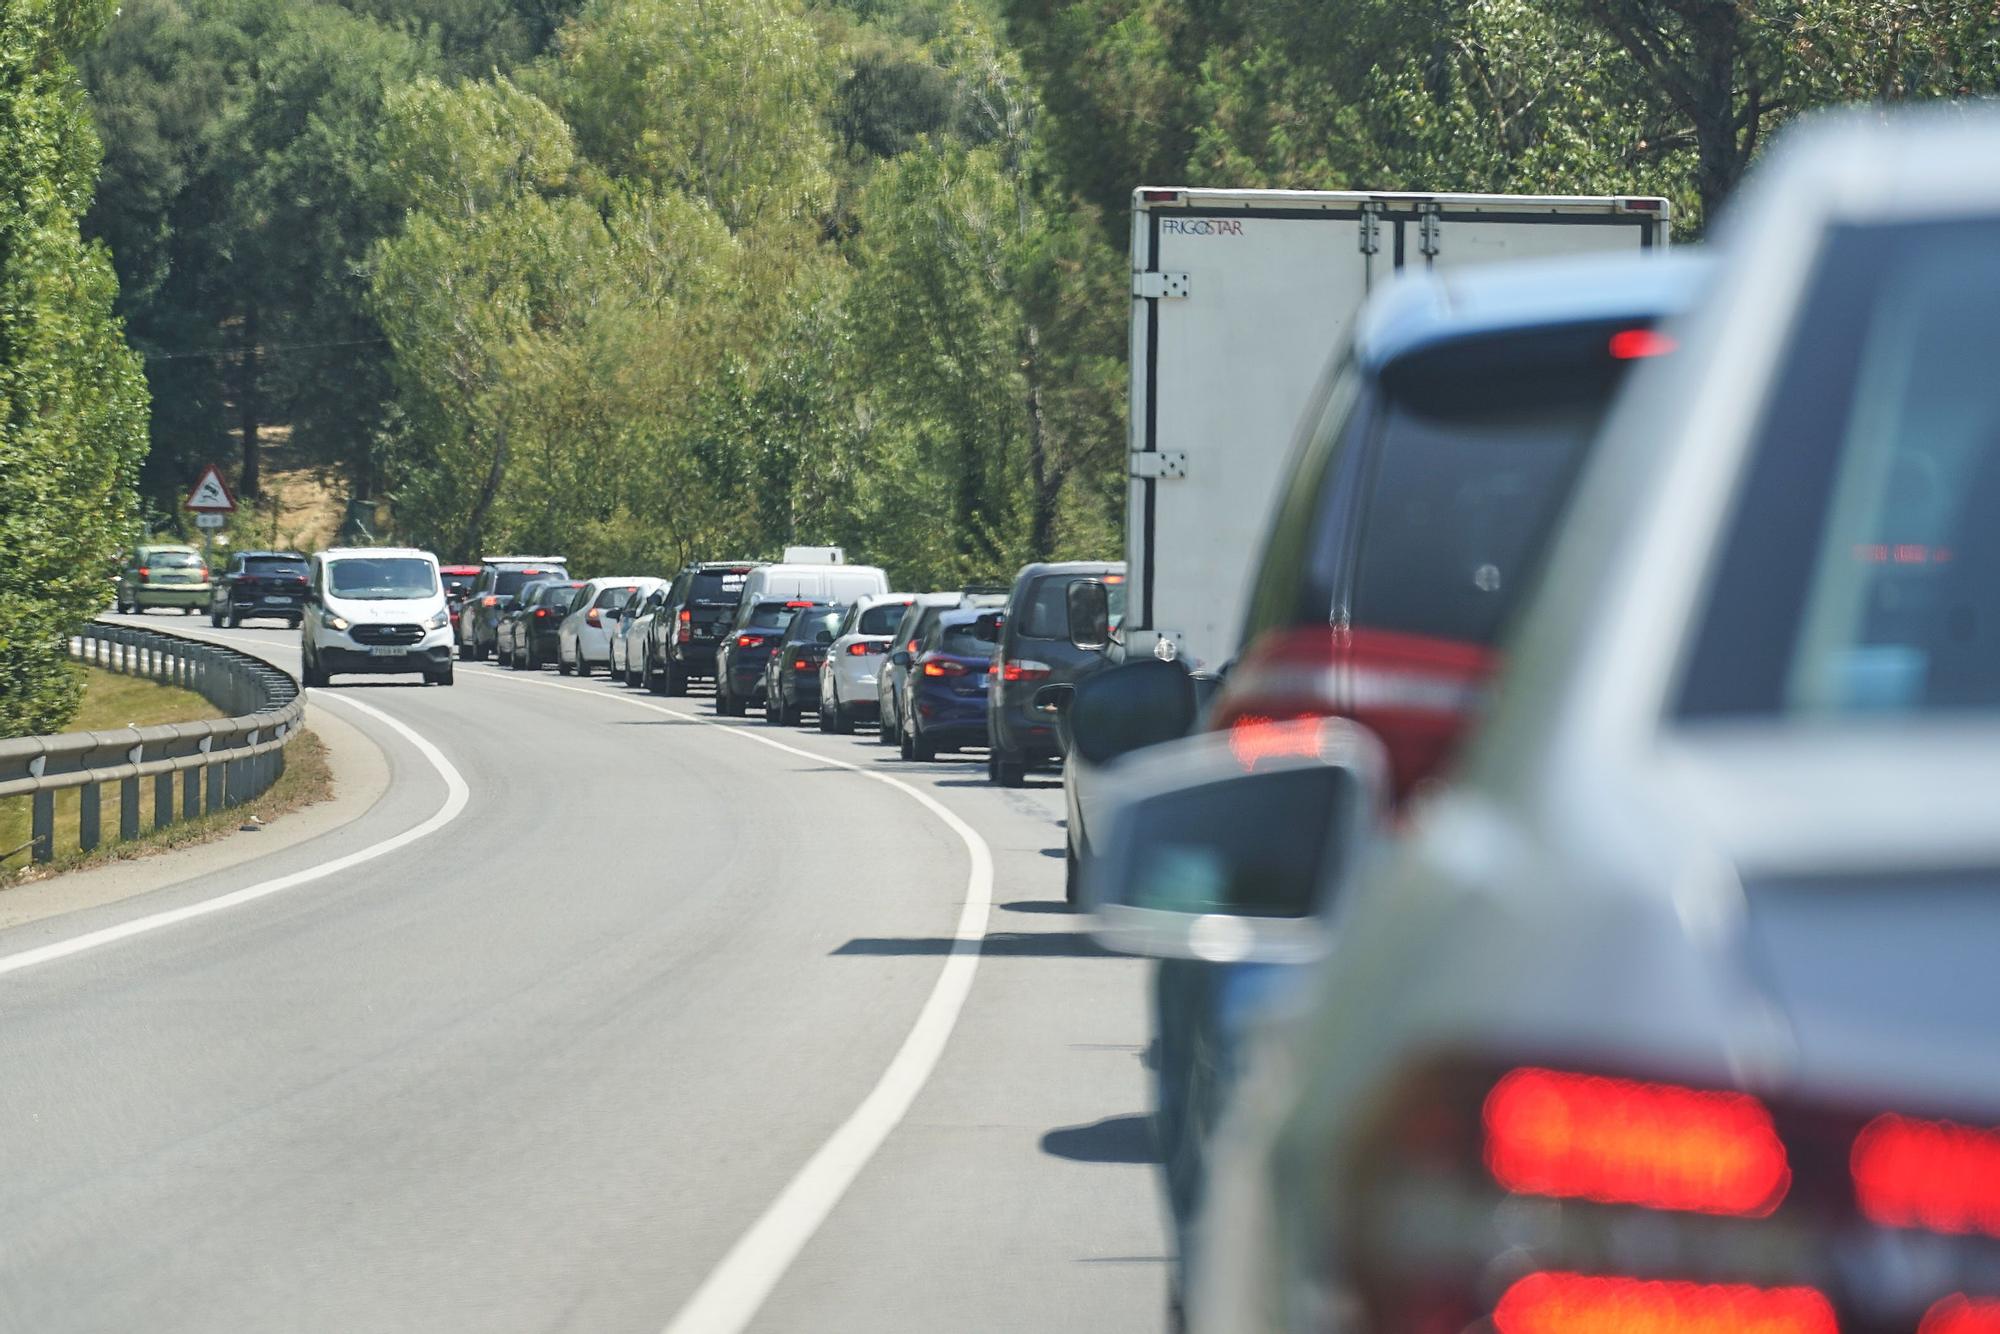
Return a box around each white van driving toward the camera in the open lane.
[298,546,452,686]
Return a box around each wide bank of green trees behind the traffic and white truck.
[70,0,2000,584]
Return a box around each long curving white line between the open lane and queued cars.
[476,672,994,1334]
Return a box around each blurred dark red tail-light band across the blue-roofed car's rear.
[1212,626,1498,800]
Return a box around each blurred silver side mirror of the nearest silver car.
[1082,718,1388,964]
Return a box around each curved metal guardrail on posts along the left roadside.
[0,620,306,862]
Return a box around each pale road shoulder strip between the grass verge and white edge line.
[0,704,390,930]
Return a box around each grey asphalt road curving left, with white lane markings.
[0,614,1166,1334]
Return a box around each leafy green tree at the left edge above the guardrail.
[0,0,146,736]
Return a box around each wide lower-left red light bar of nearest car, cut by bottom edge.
[1494,1274,1840,1334]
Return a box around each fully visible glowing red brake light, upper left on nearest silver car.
[1484,1068,1792,1216]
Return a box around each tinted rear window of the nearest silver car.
[1678,218,2000,718]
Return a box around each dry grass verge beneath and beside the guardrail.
[0,724,334,890]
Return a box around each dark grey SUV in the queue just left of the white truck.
[986,560,1124,788]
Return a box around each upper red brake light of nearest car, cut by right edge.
[1850,1114,2000,1240]
